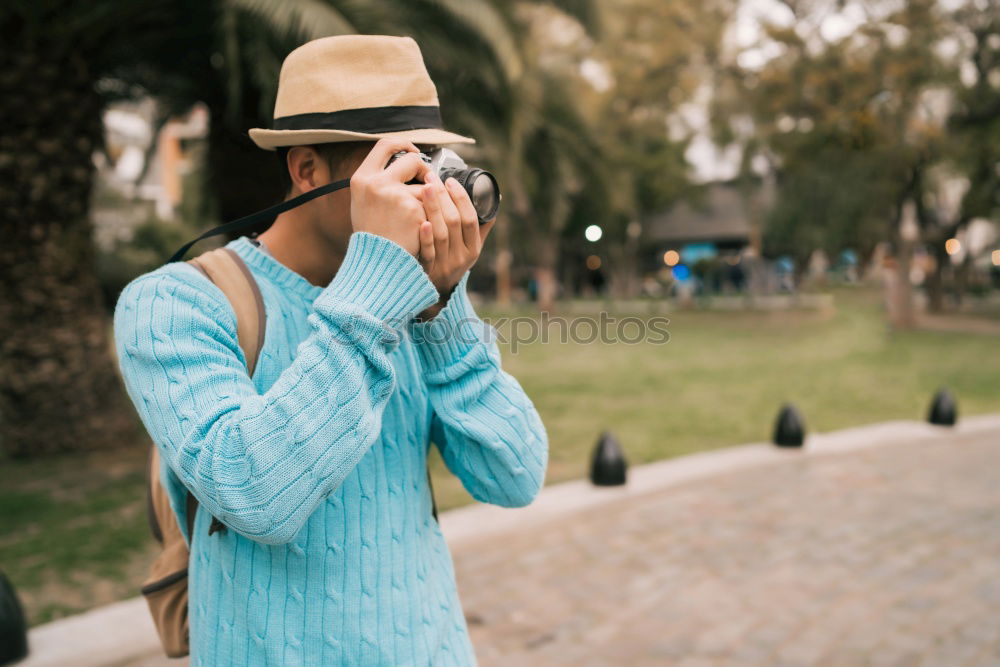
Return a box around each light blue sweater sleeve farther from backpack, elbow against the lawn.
[409,272,548,507]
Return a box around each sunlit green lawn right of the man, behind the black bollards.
[435,288,1000,506]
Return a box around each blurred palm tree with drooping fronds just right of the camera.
[438,0,615,310]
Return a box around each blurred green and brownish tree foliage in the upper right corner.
[714,0,1000,272]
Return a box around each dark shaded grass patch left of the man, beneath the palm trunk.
[0,447,154,625]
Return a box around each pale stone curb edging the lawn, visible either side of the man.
[17,414,1000,667]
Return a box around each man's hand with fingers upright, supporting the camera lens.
[418,171,496,320]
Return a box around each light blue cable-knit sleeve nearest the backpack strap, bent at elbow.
[114,233,438,544]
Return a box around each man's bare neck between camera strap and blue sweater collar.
[259,212,346,287]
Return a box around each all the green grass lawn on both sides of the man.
[0,289,1000,624]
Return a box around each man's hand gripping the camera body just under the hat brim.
[351,139,430,255]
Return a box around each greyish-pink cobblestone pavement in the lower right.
[454,433,1000,667]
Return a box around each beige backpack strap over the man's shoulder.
[188,248,266,376]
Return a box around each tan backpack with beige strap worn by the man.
[141,248,437,658]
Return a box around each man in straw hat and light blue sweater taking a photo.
[115,36,548,666]
